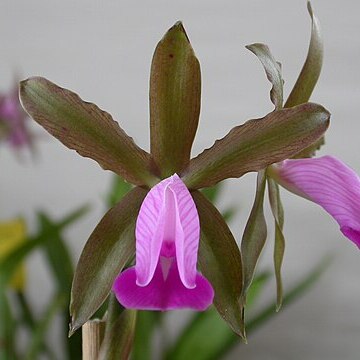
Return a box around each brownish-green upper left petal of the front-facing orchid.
[20,77,156,186]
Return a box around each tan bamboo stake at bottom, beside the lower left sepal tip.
[82,320,105,360]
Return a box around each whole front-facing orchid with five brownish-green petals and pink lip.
[20,19,330,336]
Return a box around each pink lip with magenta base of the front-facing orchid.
[114,174,214,310]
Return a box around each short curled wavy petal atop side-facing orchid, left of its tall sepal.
[246,44,284,110]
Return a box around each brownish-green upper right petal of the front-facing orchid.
[181,103,330,189]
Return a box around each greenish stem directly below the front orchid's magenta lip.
[131,311,163,360]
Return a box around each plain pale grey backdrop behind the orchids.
[0,0,360,360]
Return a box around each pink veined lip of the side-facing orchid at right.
[272,156,360,248]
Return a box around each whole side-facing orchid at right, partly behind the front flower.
[241,2,360,308]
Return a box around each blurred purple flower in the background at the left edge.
[0,86,32,150]
